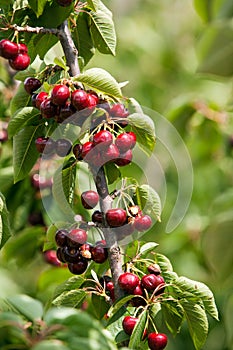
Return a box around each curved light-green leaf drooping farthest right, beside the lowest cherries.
[175,277,218,320]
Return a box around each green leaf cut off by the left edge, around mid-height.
[0,193,11,249]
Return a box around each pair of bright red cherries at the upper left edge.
[0,39,30,70]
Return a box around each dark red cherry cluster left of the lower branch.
[55,227,108,275]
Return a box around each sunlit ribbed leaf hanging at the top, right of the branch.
[89,2,116,56]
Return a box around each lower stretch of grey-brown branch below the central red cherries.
[91,167,124,299]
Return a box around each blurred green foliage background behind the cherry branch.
[0,0,233,350]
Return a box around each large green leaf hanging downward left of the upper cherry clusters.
[13,125,44,182]
